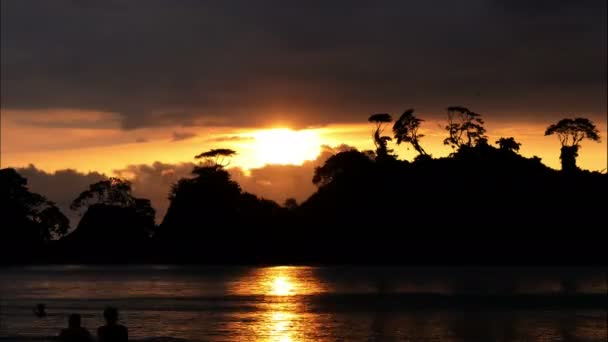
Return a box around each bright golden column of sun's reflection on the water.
[232,266,326,342]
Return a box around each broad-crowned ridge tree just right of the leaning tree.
[443,106,487,148]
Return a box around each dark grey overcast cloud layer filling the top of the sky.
[0,0,607,129]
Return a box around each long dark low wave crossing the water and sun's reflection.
[4,293,608,312]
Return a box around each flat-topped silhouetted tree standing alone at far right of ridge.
[545,118,600,171]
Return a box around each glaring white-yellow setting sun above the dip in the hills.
[252,128,322,165]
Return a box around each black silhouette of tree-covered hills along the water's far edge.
[2,107,608,264]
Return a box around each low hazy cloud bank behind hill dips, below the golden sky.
[17,145,353,227]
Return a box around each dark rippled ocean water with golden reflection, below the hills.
[0,265,608,342]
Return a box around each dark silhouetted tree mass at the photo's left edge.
[0,169,70,244]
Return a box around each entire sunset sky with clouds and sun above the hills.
[0,0,608,226]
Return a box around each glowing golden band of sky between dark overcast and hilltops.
[1,111,607,177]
